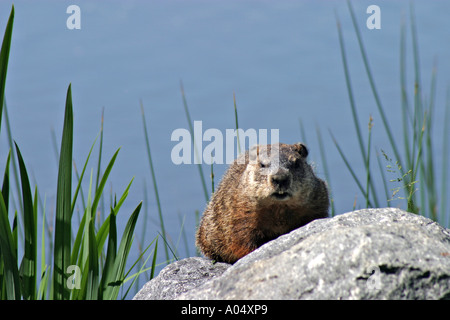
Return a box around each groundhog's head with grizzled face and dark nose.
[238,143,319,205]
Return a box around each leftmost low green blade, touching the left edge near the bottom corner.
[0,192,21,300]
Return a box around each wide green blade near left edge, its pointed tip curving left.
[16,144,37,300]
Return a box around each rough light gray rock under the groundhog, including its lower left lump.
[137,208,450,299]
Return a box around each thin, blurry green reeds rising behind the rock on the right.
[332,1,450,228]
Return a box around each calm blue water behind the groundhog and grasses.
[0,1,450,296]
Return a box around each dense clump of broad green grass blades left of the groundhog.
[0,7,157,300]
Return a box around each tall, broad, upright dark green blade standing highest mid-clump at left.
[53,85,73,300]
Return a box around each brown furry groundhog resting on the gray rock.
[196,143,329,263]
